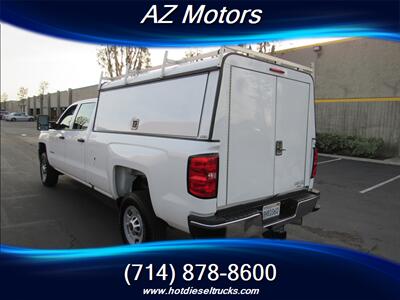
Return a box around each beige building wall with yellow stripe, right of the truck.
[276,39,400,156]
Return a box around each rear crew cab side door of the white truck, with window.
[64,102,96,182]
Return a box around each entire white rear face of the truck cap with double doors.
[213,55,315,207]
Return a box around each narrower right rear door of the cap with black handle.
[274,78,310,194]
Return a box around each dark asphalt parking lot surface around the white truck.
[1,121,400,262]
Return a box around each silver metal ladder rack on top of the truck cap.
[99,46,314,89]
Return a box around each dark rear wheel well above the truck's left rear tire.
[114,166,149,206]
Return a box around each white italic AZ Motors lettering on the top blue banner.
[140,4,263,24]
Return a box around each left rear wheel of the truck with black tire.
[119,191,166,244]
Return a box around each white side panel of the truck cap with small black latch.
[95,74,208,137]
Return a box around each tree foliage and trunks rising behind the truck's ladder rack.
[97,46,151,78]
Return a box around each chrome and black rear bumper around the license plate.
[188,190,320,237]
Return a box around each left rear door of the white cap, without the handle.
[227,67,276,205]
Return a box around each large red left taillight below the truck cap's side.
[188,154,219,199]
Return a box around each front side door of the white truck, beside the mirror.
[46,105,77,171]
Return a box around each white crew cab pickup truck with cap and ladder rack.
[38,48,319,244]
